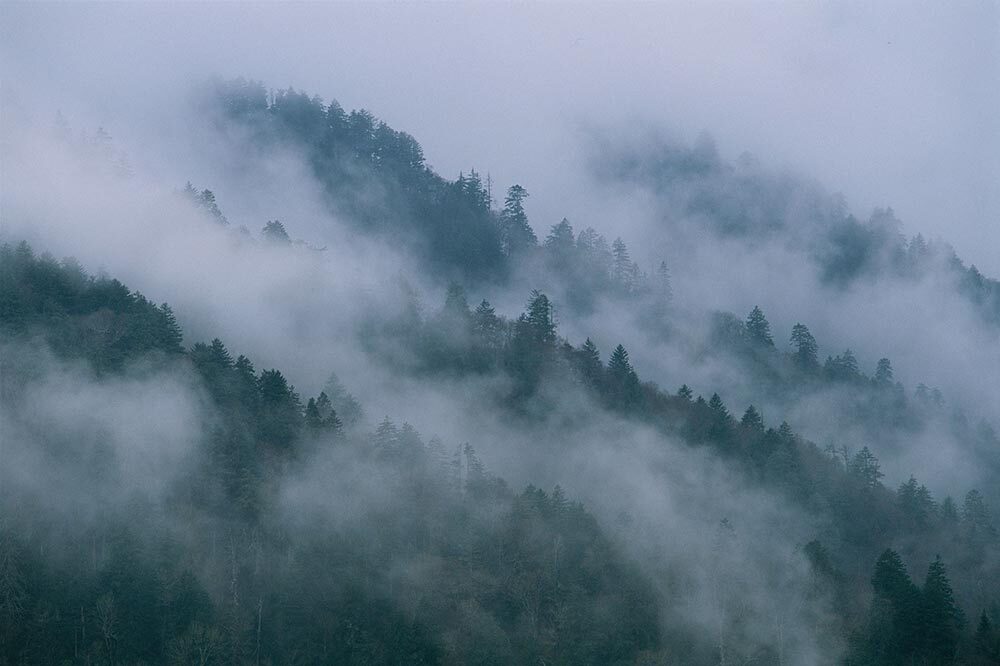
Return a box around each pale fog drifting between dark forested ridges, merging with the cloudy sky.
[0,3,1000,664]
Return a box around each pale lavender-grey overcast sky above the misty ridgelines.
[0,2,1000,276]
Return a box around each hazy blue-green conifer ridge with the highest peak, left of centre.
[206,79,669,307]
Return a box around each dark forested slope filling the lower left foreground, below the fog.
[0,243,659,664]
